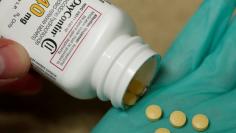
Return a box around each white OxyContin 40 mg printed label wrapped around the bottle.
[0,0,104,80]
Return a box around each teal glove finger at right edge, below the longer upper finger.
[168,15,236,94]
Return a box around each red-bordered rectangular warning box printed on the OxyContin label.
[50,6,101,71]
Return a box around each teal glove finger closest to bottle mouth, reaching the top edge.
[156,0,236,86]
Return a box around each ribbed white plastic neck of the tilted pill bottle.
[92,35,157,108]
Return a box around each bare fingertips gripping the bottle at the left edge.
[0,39,41,94]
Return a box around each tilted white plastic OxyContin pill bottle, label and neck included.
[0,0,160,108]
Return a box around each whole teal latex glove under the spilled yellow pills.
[93,0,236,133]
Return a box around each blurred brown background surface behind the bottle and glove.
[0,0,201,133]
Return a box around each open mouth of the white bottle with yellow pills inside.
[123,57,158,108]
